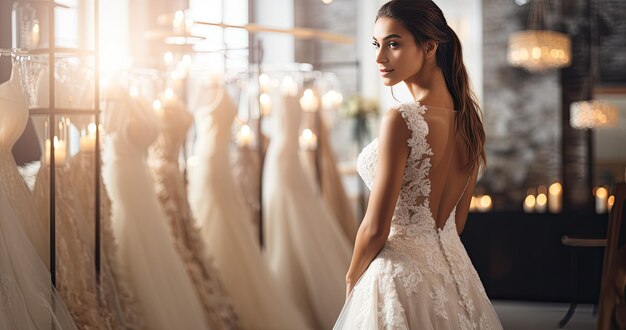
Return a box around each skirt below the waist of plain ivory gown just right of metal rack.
[103,155,208,330]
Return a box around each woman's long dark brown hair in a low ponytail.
[376,0,487,168]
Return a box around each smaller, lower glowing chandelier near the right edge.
[570,100,619,129]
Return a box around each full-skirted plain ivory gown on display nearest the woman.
[263,96,352,329]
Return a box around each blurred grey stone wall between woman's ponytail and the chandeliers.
[478,0,561,209]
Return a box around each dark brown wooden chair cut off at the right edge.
[596,182,626,330]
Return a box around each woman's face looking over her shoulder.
[372,17,424,86]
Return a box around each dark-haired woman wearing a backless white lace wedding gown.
[335,0,502,329]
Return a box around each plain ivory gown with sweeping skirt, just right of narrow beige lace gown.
[189,87,308,329]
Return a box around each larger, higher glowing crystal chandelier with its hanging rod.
[507,0,572,72]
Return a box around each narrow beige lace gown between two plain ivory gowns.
[149,96,237,329]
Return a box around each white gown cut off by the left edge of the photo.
[0,61,76,330]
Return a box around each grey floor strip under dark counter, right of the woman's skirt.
[493,300,595,330]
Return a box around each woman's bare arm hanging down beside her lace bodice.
[346,109,411,296]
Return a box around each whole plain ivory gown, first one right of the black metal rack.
[103,88,209,330]
